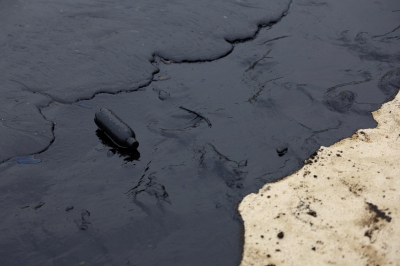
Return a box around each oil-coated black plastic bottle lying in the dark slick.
[94,108,139,149]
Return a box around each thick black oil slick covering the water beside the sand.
[0,0,400,265]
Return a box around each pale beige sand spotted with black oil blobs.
[239,89,400,265]
